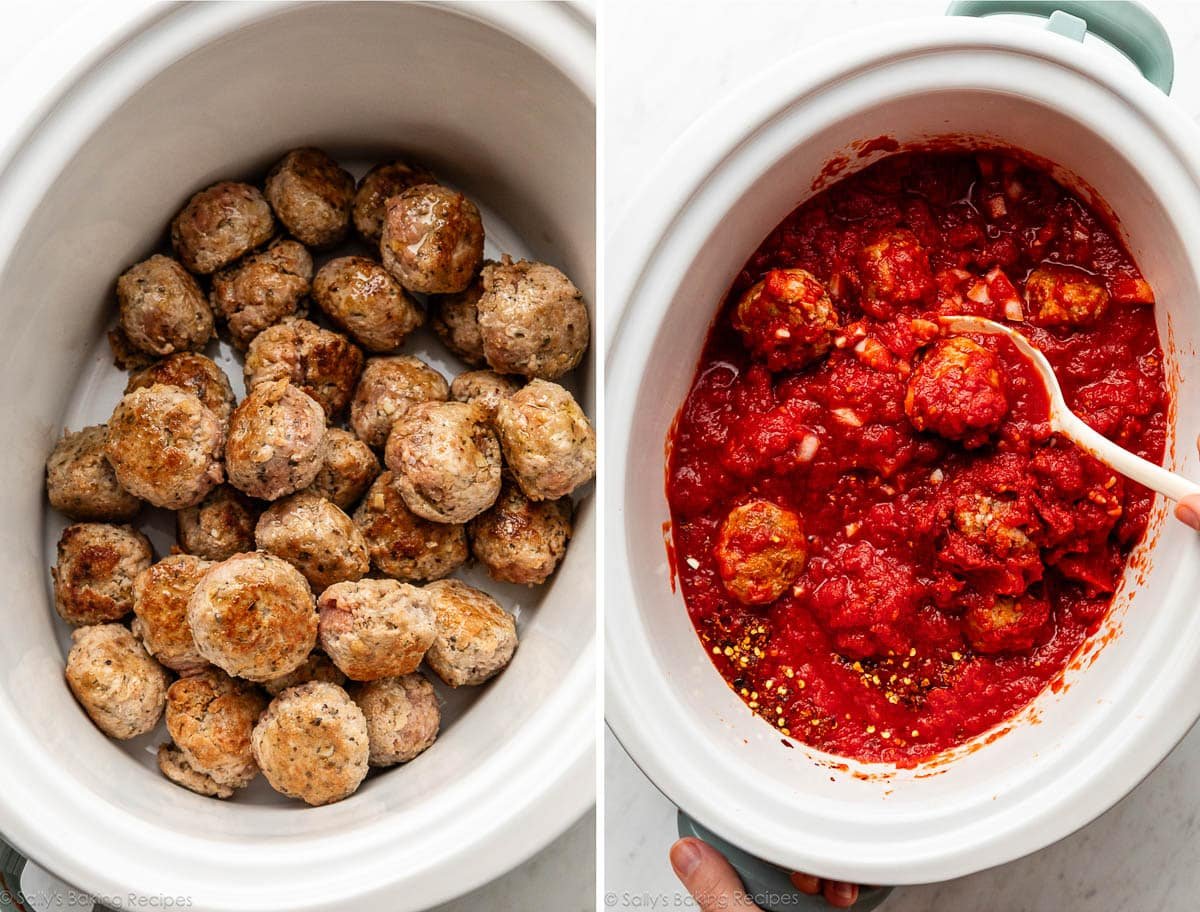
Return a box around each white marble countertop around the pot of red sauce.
[602,0,1200,912]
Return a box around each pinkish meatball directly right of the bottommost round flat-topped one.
[354,674,442,767]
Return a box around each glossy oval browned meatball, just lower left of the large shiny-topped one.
[312,257,425,352]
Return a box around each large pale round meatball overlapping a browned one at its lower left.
[384,402,500,522]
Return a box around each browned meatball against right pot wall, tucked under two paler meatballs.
[468,479,571,586]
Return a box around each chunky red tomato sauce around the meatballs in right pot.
[667,152,1170,766]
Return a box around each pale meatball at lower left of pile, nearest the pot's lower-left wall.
[67,624,167,740]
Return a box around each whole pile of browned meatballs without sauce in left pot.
[47,149,595,805]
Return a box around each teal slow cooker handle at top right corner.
[946,0,1175,95]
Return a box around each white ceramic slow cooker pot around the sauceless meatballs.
[0,4,594,911]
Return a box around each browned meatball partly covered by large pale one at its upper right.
[354,472,467,581]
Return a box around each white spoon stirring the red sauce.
[937,317,1200,500]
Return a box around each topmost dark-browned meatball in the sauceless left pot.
[266,149,354,247]
